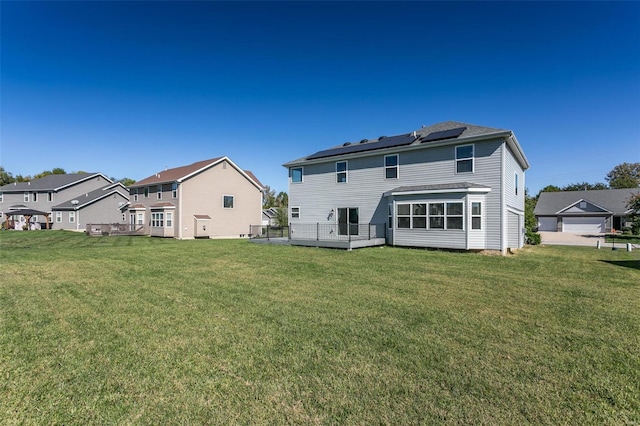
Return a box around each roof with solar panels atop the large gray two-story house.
[283,121,529,170]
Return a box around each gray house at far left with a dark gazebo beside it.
[0,173,129,231]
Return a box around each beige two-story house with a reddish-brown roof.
[128,157,263,239]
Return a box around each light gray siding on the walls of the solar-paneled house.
[289,139,510,250]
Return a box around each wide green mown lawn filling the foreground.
[0,231,640,425]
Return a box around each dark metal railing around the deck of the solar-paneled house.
[289,223,387,241]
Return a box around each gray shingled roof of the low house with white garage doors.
[533,188,640,216]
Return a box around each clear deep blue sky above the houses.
[0,1,640,194]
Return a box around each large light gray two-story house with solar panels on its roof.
[284,121,529,253]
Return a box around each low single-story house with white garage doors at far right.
[533,188,640,234]
